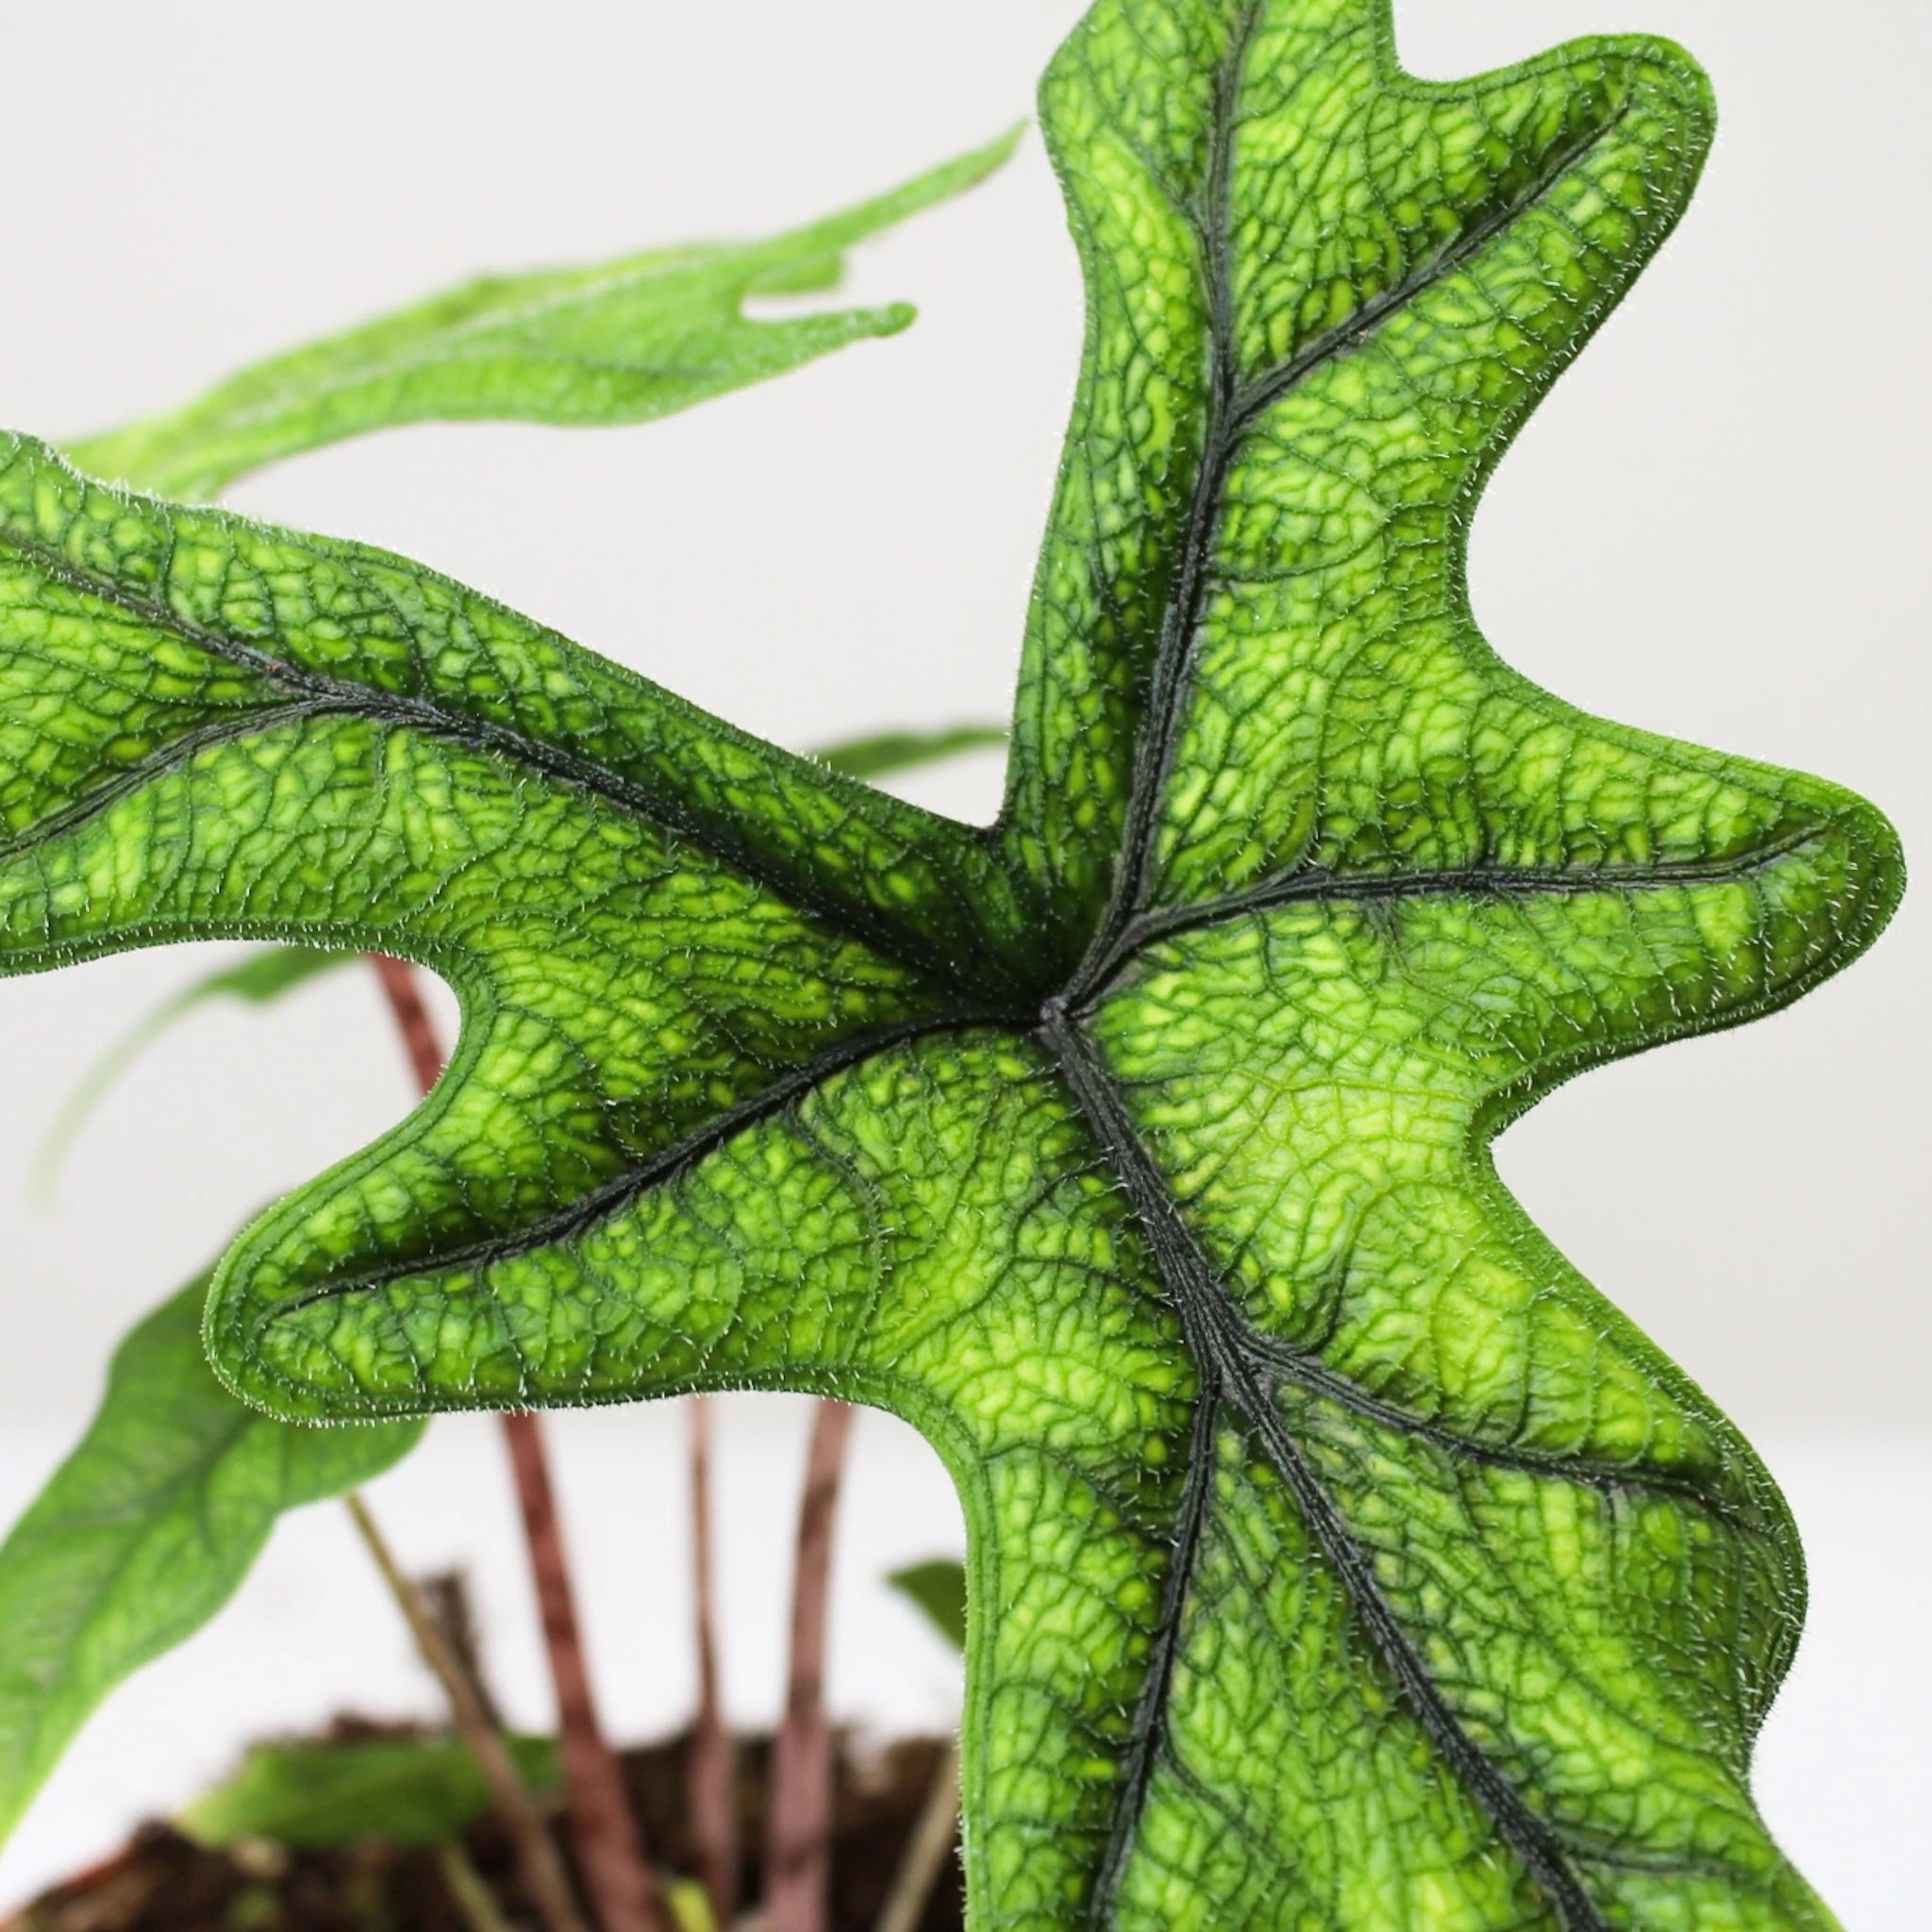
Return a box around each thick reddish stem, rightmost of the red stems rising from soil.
[765,1401,852,1932]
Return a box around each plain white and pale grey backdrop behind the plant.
[0,0,1932,1932]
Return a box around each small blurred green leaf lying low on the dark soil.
[175,1737,560,1851]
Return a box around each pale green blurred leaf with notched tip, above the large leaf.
[72,129,1020,500]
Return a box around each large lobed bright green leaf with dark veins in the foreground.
[0,0,1903,1932]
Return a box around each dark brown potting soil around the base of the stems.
[0,1722,966,1932]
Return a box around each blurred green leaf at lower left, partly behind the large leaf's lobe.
[0,1275,424,1840]
